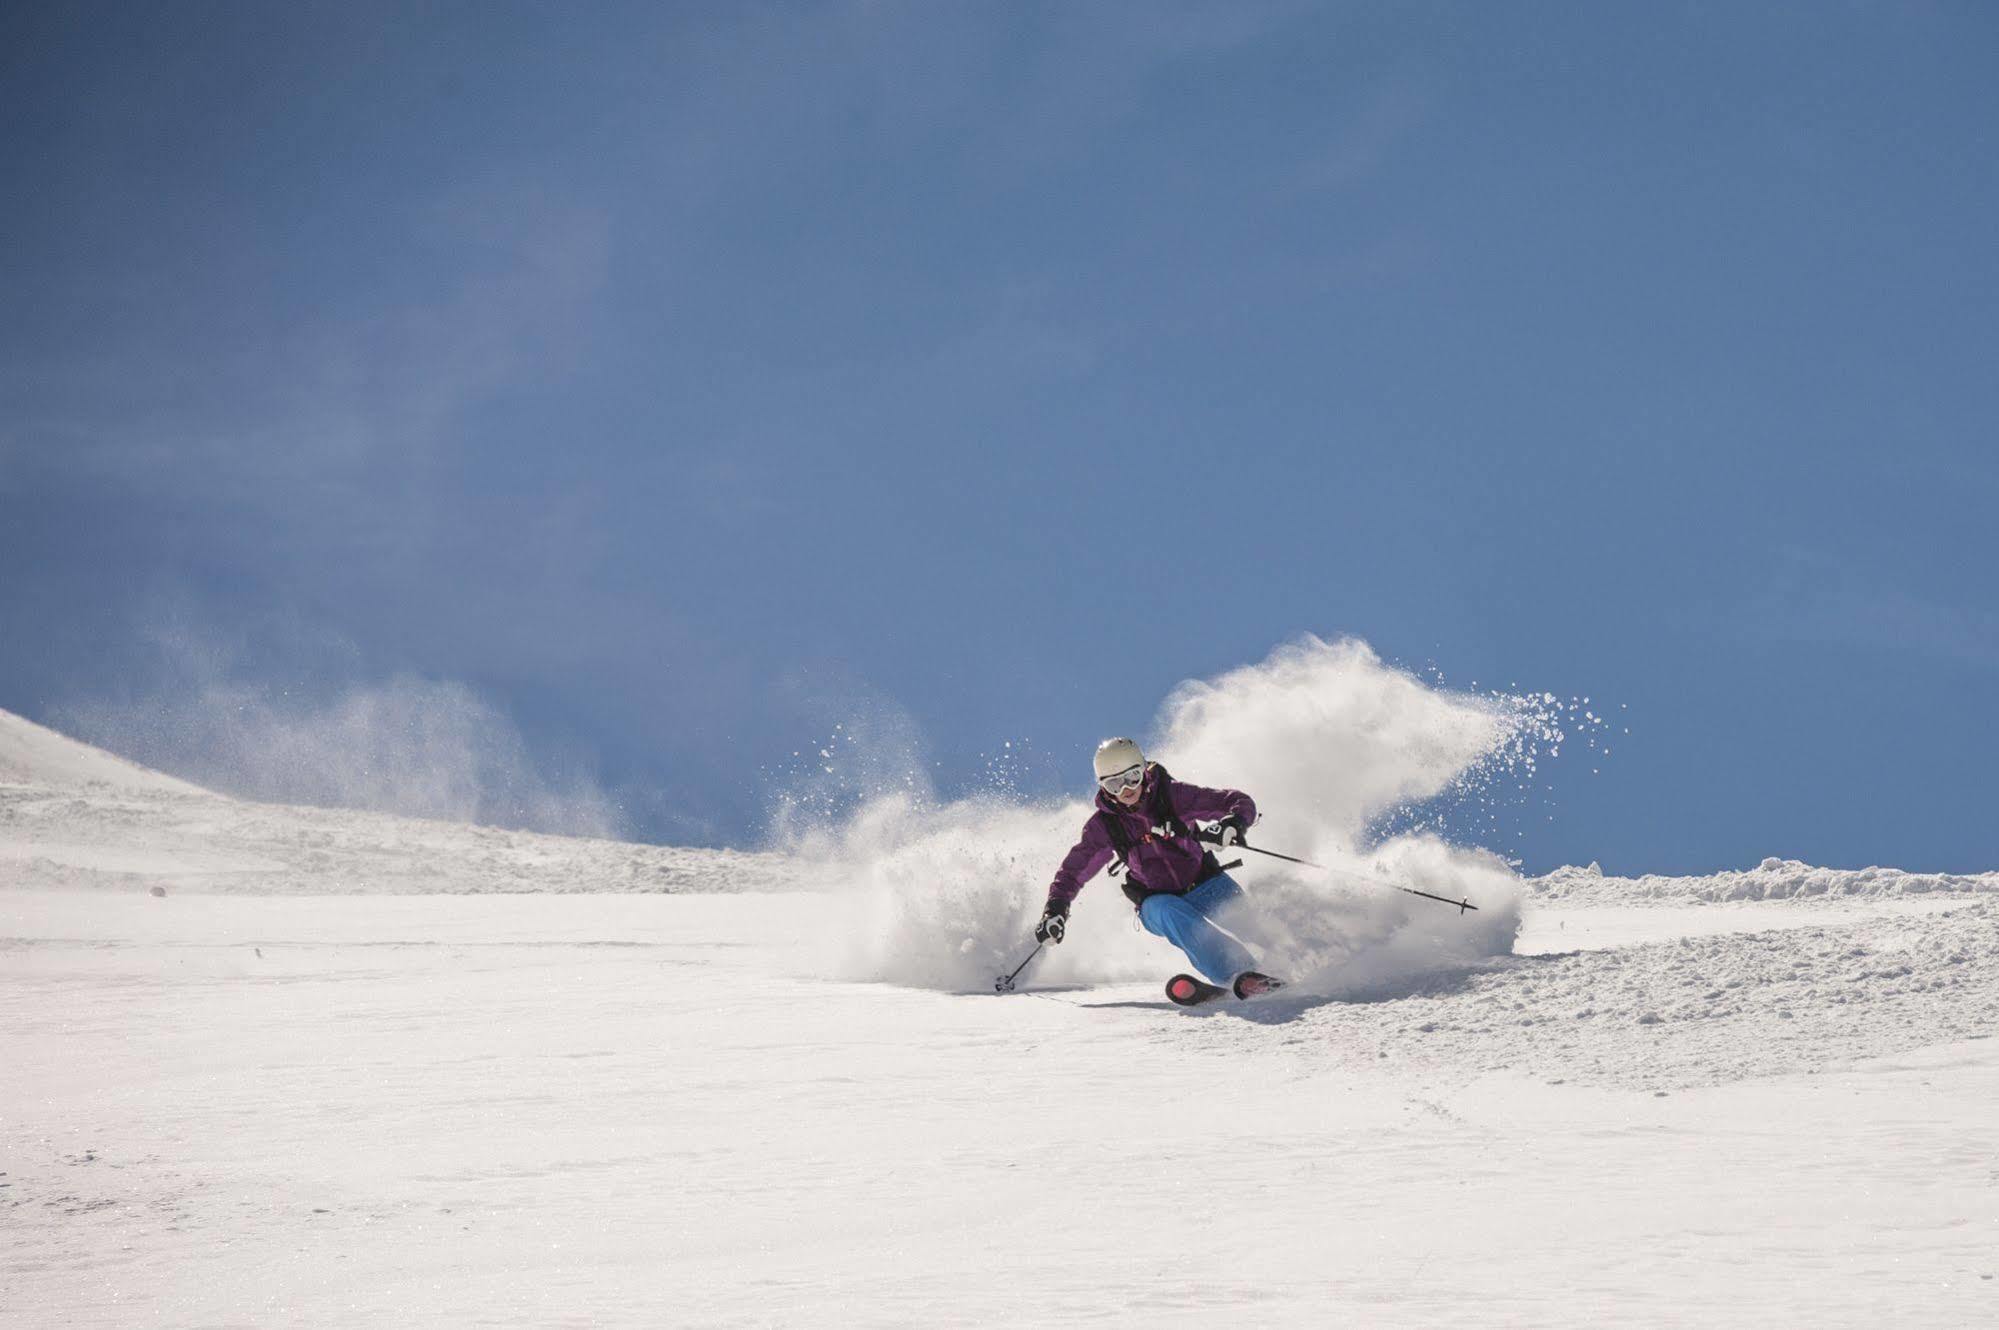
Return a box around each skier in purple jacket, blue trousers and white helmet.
[1033,738,1283,1006]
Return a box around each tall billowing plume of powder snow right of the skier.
[1157,636,1531,994]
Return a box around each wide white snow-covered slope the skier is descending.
[11,700,1999,1326]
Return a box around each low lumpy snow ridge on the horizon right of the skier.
[1527,858,1999,904]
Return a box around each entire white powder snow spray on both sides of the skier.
[788,636,1583,996]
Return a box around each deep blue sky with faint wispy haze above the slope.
[0,4,1999,870]
